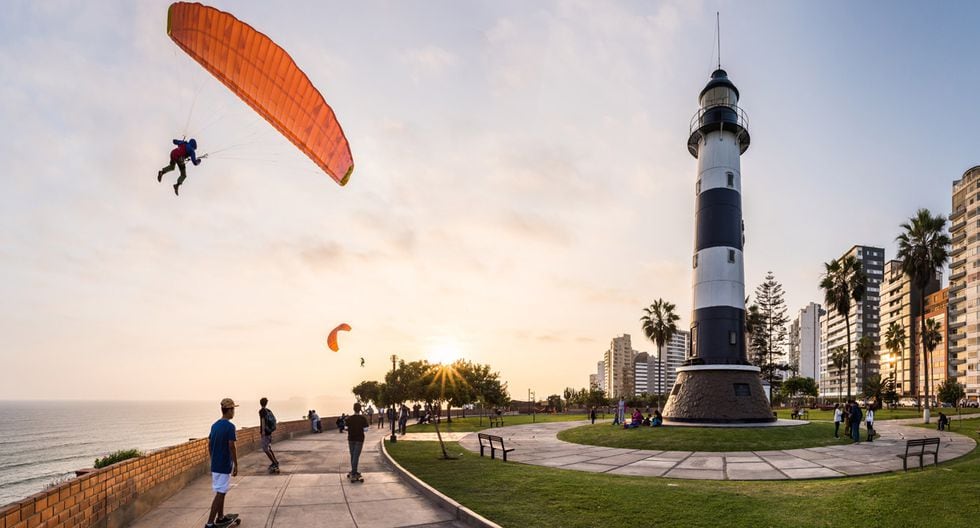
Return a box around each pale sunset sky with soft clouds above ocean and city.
[0,0,980,400]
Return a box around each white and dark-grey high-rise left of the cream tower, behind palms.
[819,246,885,399]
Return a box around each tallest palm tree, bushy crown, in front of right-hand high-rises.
[895,209,951,423]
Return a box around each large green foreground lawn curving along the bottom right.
[387,442,980,528]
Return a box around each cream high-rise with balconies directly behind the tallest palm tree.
[878,260,946,397]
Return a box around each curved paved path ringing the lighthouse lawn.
[460,421,976,480]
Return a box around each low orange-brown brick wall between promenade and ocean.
[0,417,322,528]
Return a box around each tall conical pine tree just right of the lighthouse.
[752,271,789,401]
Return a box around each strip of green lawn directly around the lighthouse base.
[558,422,851,451]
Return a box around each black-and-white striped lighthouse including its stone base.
[664,65,775,423]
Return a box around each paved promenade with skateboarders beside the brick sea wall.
[132,428,463,528]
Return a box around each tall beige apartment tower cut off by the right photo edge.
[948,165,980,401]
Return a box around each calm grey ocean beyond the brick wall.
[0,398,353,506]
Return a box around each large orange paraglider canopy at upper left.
[167,2,354,185]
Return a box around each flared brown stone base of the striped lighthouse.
[663,365,776,424]
